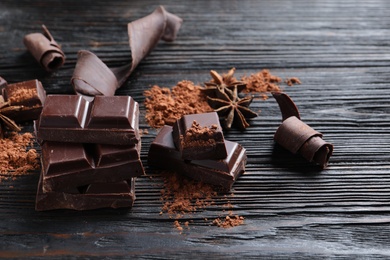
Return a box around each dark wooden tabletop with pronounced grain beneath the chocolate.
[0,0,390,259]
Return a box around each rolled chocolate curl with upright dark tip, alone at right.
[272,92,333,168]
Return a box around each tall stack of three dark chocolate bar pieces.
[35,95,144,211]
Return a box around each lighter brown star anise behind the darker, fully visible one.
[201,68,246,97]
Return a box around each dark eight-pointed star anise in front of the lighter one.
[207,87,257,129]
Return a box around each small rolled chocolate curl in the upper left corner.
[23,25,65,72]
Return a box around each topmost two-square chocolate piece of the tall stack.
[36,95,140,145]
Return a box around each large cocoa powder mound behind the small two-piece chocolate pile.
[144,80,212,128]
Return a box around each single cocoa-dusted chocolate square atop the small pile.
[172,112,227,160]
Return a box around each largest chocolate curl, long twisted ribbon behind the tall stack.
[71,6,182,96]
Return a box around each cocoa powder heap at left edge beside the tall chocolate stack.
[0,132,39,181]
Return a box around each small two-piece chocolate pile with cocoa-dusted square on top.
[148,112,247,191]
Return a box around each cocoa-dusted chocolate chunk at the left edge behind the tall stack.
[2,79,46,122]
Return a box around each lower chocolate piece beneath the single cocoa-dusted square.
[148,126,247,191]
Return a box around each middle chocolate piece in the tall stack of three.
[41,142,145,193]
